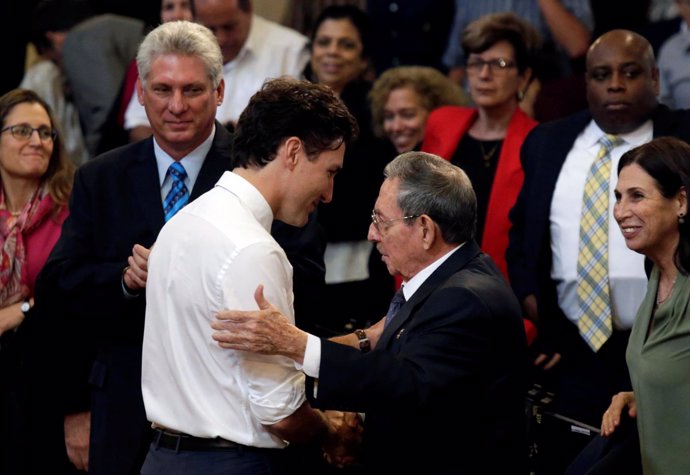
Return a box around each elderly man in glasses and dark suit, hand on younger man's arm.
[213,152,527,474]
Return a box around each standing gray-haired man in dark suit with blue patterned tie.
[26,22,231,475]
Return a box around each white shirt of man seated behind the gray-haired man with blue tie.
[125,15,309,130]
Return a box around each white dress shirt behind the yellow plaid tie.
[550,121,653,330]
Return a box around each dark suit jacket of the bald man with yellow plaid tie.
[506,105,690,425]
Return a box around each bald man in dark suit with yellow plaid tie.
[506,30,690,473]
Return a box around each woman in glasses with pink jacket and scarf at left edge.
[0,89,74,334]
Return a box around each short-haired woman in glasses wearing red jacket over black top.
[422,13,539,278]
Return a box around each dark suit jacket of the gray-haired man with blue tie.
[28,123,231,474]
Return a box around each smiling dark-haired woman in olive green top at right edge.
[601,137,690,475]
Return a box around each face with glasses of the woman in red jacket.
[465,41,531,109]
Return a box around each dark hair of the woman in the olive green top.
[618,137,690,274]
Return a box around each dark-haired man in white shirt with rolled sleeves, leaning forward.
[142,78,357,475]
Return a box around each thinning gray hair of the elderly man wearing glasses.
[383,151,477,244]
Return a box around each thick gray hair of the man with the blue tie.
[137,21,223,89]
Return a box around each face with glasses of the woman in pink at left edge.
[0,102,55,182]
